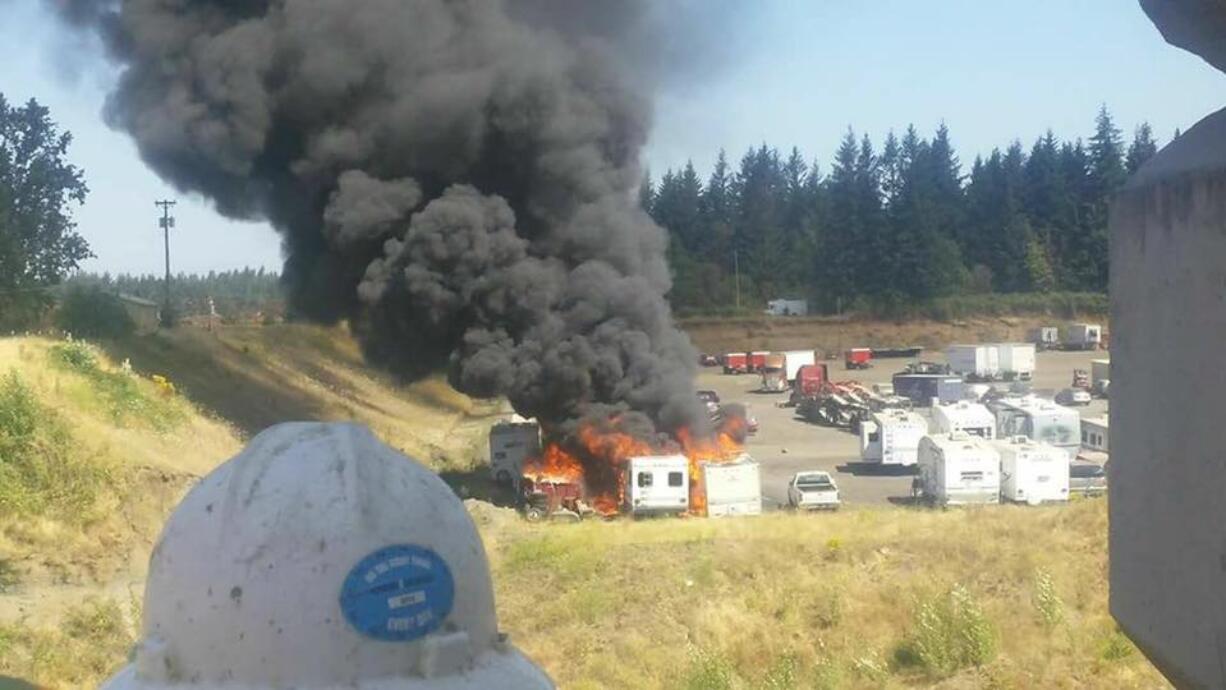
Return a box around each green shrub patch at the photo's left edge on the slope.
[0,373,113,521]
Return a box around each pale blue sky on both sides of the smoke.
[0,0,1226,272]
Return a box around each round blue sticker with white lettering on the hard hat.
[341,544,456,642]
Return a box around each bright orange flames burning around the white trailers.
[524,415,748,516]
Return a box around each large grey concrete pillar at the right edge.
[1110,110,1226,688]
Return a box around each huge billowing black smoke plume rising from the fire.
[55,0,704,433]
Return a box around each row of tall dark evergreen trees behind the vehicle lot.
[640,107,1157,314]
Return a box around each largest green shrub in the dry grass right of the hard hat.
[894,585,996,678]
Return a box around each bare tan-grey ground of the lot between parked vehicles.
[696,352,1108,507]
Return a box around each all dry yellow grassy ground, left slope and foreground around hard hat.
[0,326,1163,690]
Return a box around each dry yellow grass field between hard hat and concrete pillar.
[483,501,1163,689]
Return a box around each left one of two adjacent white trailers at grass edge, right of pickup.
[918,431,1000,505]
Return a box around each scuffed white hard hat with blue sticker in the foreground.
[103,424,553,690]
